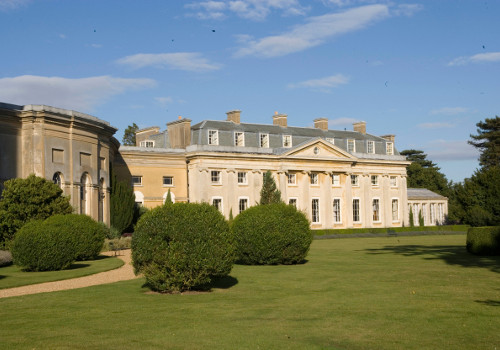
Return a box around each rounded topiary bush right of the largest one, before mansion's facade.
[232,203,312,265]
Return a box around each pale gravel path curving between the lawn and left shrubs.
[0,249,138,298]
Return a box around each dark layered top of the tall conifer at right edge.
[468,116,500,168]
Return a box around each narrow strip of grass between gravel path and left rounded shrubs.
[0,255,123,289]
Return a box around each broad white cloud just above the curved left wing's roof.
[0,75,156,112]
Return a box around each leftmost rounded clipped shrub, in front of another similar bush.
[11,220,76,271]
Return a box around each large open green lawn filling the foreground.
[0,235,500,350]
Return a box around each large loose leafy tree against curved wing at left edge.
[0,174,73,242]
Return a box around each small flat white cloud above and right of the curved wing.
[116,52,221,72]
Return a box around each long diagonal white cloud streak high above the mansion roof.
[235,5,389,57]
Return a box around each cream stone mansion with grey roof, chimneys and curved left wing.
[0,103,448,229]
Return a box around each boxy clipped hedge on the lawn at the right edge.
[466,226,500,255]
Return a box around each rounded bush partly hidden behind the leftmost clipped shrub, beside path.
[45,214,109,261]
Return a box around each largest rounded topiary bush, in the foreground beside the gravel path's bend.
[132,203,235,292]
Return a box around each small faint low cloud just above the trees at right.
[424,140,479,161]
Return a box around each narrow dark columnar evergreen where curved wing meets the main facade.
[110,175,135,234]
